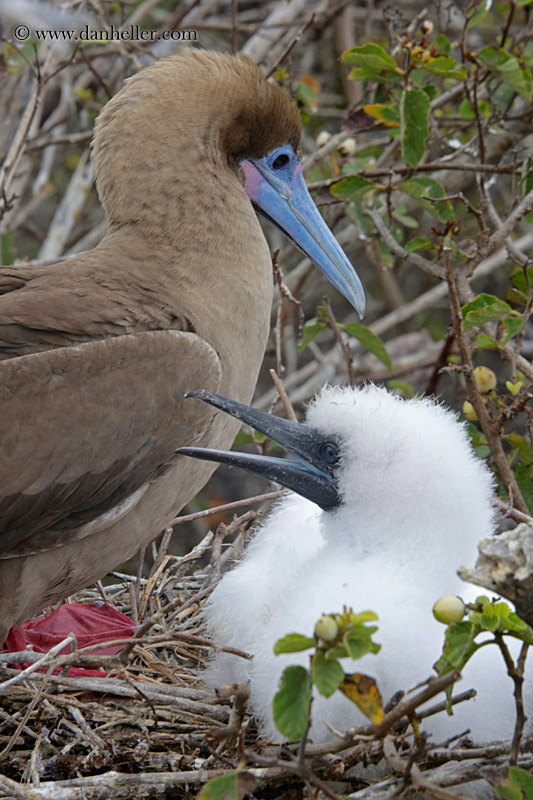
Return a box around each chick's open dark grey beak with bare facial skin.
[176,389,341,511]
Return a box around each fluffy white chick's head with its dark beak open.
[177,385,492,545]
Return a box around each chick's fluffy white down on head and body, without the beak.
[206,385,528,741]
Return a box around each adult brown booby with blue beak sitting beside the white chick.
[0,50,364,642]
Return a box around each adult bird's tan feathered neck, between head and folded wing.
[95,161,272,397]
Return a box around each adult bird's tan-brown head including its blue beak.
[93,49,365,316]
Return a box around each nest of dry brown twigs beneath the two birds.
[0,511,533,800]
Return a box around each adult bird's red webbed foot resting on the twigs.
[0,603,135,678]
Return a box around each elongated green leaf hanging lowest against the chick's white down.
[272,666,312,742]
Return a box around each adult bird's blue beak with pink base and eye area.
[240,145,365,318]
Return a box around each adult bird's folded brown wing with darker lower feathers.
[0,331,221,558]
